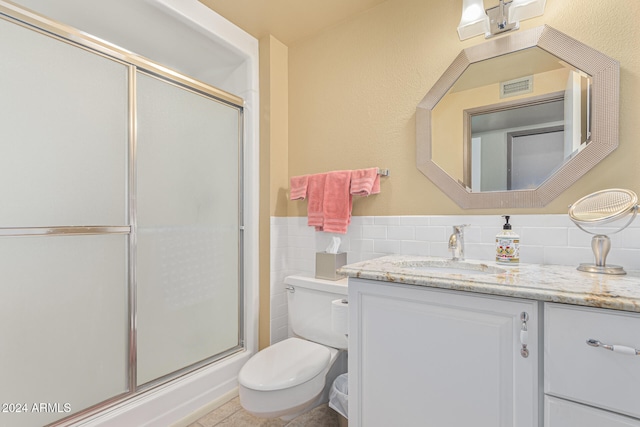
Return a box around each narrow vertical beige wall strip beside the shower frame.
[258,36,289,349]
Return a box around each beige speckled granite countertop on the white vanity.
[338,255,640,313]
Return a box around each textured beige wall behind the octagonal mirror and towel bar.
[286,0,640,216]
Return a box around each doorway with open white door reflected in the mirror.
[470,75,591,192]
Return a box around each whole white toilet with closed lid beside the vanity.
[238,276,348,420]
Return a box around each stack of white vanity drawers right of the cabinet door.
[544,303,640,427]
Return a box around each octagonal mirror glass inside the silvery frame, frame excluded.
[432,47,591,192]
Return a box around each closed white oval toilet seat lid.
[238,338,331,391]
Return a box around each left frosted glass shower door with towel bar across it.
[0,14,130,427]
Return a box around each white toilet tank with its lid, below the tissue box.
[284,276,348,349]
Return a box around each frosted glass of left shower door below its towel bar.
[0,235,128,427]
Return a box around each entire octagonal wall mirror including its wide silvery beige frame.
[416,26,619,208]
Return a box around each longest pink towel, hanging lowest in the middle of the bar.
[322,171,352,234]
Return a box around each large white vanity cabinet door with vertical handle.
[349,279,539,427]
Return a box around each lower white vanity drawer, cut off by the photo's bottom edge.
[544,396,640,427]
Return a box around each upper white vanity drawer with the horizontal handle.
[544,304,640,417]
